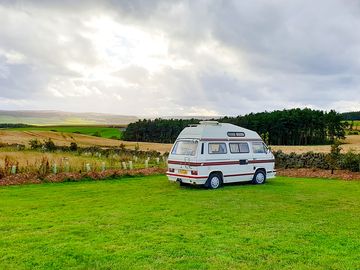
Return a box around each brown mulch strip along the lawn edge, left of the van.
[0,168,166,186]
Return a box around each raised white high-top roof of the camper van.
[178,121,261,140]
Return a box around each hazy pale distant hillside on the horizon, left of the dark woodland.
[0,110,138,125]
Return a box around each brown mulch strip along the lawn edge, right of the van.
[276,169,360,181]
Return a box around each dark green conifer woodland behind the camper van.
[123,108,346,145]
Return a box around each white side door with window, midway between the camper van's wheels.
[224,142,254,183]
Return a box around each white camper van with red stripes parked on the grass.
[166,121,276,189]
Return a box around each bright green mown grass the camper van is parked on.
[0,176,360,269]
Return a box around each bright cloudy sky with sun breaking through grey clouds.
[0,0,360,116]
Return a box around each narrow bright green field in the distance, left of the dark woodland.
[13,126,122,139]
